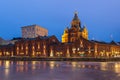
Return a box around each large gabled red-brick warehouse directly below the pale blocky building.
[14,36,58,57]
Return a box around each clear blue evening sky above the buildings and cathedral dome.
[0,0,120,42]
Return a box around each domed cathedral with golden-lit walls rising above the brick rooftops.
[62,12,88,43]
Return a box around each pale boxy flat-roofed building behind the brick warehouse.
[22,25,48,38]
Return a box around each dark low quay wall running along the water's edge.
[0,57,120,62]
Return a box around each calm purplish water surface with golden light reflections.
[0,61,120,80]
